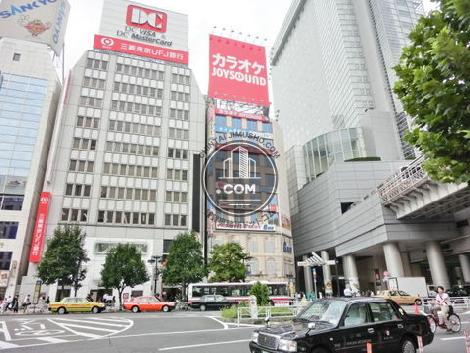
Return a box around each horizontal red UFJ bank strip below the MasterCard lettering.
[93,34,188,65]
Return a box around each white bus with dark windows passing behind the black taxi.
[188,281,292,305]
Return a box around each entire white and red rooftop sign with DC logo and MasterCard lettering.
[94,0,188,64]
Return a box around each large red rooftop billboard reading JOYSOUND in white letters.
[208,35,269,107]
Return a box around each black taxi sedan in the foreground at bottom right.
[250,298,434,353]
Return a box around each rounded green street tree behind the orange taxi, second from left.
[101,244,149,308]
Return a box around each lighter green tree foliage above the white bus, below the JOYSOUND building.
[209,243,248,282]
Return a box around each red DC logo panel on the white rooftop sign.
[126,5,167,33]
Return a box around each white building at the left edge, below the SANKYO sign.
[0,38,61,299]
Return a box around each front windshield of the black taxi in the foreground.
[296,300,346,326]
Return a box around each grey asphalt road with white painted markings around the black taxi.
[0,312,470,353]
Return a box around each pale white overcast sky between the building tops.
[65,0,431,93]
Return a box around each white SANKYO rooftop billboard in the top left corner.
[0,0,70,55]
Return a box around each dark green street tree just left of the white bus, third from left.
[162,233,207,298]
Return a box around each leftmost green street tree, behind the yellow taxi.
[38,225,89,296]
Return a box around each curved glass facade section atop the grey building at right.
[304,128,367,181]
